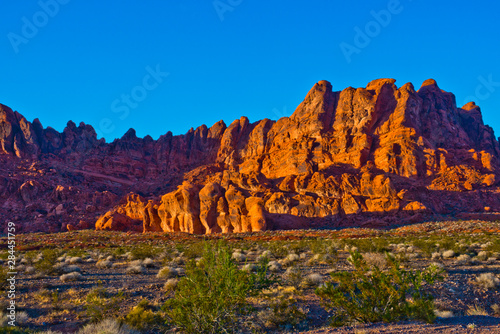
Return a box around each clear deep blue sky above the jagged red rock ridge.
[0,0,500,141]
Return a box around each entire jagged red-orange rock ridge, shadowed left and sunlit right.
[0,79,500,233]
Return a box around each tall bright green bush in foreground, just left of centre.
[163,244,268,333]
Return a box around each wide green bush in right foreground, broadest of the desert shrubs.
[316,252,443,326]
